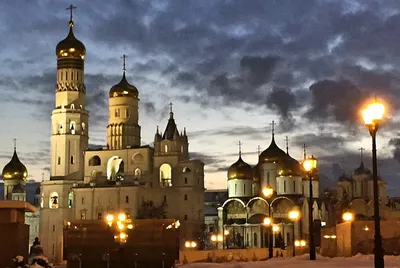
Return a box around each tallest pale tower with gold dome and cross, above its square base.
[50,5,89,180]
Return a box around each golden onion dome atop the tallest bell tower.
[56,20,86,59]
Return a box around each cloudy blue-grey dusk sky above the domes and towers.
[0,0,400,195]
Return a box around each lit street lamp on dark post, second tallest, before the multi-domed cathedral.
[303,156,318,260]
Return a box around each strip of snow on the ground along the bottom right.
[179,254,400,268]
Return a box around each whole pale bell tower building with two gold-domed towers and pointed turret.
[34,11,204,263]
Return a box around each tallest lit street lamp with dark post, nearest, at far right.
[362,99,385,268]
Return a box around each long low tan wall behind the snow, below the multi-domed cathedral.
[179,248,288,264]
